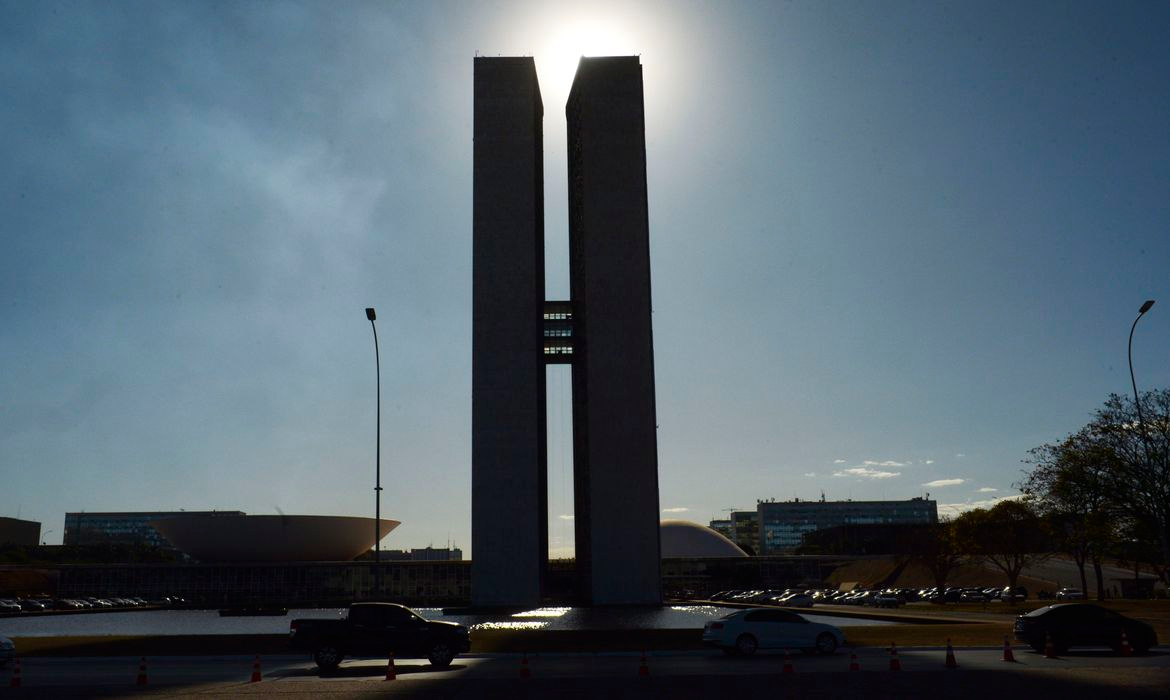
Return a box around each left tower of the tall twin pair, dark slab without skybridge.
[472,59,549,605]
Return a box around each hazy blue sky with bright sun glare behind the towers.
[0,2,1170,553]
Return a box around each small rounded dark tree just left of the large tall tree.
[954,500,1051,588]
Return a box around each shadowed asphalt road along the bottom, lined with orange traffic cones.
[0,647,1170,700]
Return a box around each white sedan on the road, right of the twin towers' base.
[703,608,845,656]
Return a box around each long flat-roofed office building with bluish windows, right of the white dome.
[756,497,938,556]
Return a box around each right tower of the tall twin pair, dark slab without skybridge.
[565,56,661,604]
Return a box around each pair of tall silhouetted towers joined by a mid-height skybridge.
[472,56,661,606]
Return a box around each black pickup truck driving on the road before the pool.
[289,603,472,671]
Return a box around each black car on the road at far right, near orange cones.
[1014,603,1158,653]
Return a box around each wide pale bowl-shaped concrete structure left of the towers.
[151,515,401,562]
